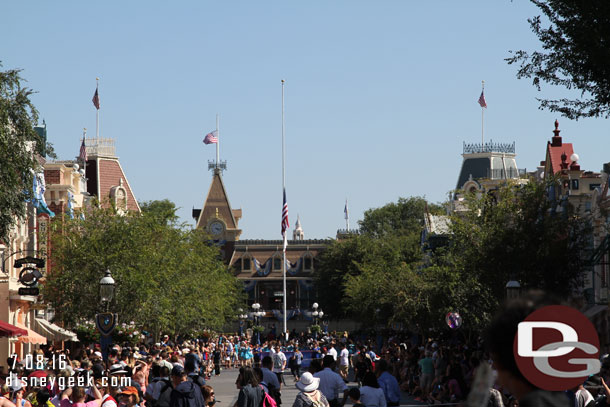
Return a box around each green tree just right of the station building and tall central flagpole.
[315,197,432,323]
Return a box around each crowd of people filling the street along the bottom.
[0,310,610,407]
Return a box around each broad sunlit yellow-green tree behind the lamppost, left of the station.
[43,203,243,334]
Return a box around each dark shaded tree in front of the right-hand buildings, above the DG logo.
[448,181,590,302]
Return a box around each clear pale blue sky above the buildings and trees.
[0,0,610,239]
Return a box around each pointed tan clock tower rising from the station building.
[193,168,241,261]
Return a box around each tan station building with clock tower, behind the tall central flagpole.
[193,168,329,332]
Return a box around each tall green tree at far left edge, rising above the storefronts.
[0,64,42,241]
